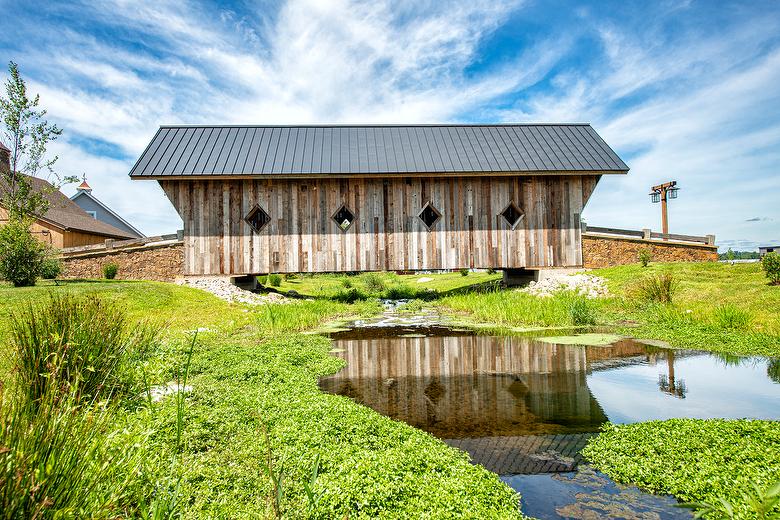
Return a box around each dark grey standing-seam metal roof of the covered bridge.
[130,124,628,178]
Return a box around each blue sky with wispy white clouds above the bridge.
[0,0,780,250]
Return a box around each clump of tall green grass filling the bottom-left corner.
[0,382,142,519]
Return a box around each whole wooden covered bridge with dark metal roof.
[130,124,628,276]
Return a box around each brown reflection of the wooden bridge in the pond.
[320,336,672,473]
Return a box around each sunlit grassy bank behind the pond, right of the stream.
[438,263,780,356]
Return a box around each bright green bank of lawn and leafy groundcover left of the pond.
[0,282,521,518]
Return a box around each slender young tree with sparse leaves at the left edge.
[0,62,75,220]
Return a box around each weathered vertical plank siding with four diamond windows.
[160,175,598,275]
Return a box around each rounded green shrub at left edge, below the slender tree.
[0,217,46,287]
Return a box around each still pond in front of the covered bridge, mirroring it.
[320,321,780,518]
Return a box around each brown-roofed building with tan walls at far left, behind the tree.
[0,143,137,248]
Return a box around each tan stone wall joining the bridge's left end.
[62,242,184,282]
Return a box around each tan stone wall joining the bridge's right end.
[582,234,718,268]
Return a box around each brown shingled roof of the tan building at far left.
[0,176,136,239]
